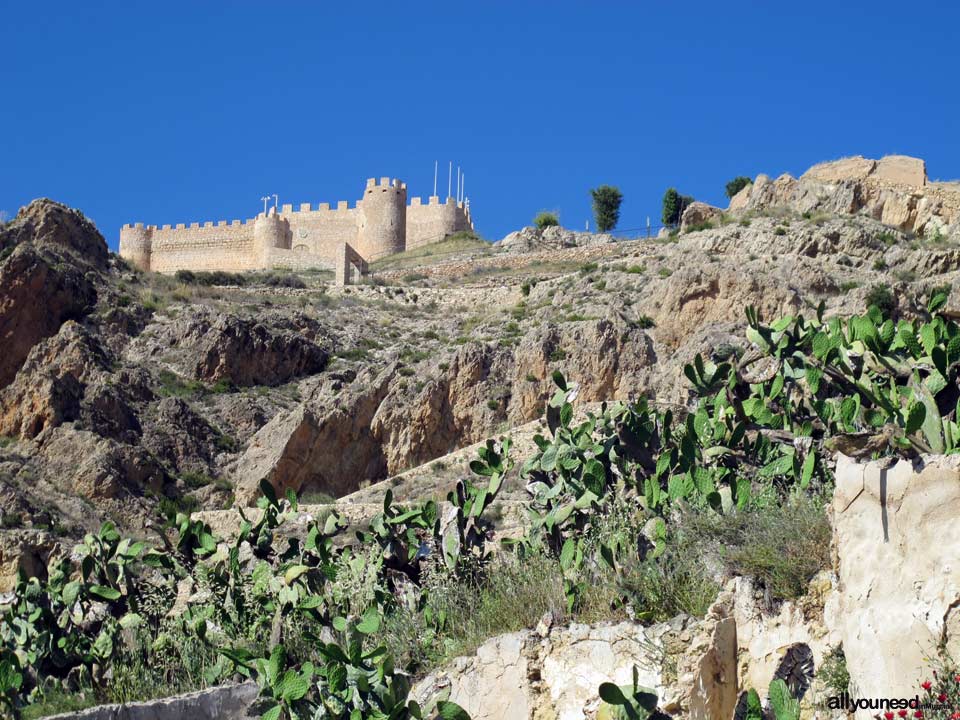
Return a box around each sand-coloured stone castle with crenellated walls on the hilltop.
[120,177,473,282]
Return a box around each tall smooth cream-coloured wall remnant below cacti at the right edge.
[829,455,960,704]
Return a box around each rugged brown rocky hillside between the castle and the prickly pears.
[0,188,960,583]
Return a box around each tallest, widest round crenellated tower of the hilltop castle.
[356,177,407,262]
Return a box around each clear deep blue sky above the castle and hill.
[0,0,960,248]
